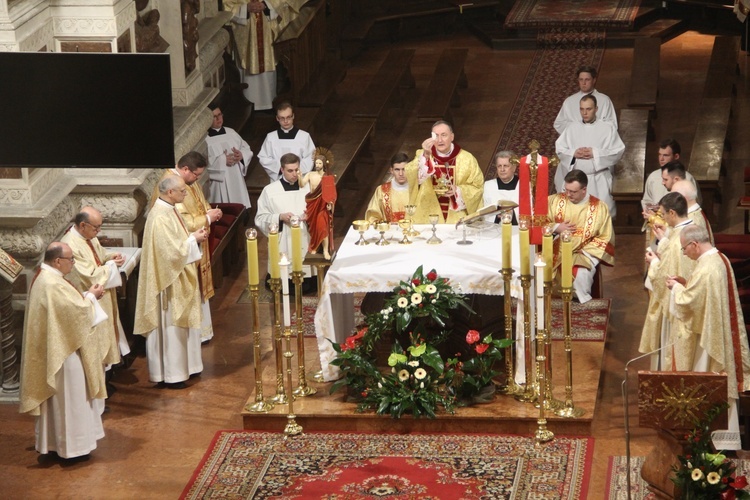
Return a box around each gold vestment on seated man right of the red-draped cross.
[549,193,615,270]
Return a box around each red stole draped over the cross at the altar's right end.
[518,155,549,245]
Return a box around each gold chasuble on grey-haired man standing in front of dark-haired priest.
[133,203,201,336]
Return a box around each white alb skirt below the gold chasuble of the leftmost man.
[35,351,104,458]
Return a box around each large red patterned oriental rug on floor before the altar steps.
[181,431,594,500]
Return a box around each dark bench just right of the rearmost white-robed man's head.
[628,38,661,117]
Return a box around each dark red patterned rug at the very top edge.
[505,0,641,29]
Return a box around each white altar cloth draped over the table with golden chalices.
[315,224,535,381]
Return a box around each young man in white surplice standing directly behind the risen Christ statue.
[255,153,312,277]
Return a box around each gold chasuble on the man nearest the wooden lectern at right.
[672,249,750,399]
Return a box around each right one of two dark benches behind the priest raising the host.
[417,49,469,123]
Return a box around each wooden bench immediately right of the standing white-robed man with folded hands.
[612,108,649,233]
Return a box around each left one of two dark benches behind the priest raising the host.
[352,49,414,126]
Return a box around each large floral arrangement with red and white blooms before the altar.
[330,266,512,418]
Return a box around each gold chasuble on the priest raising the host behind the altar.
[406,144,484,224]
